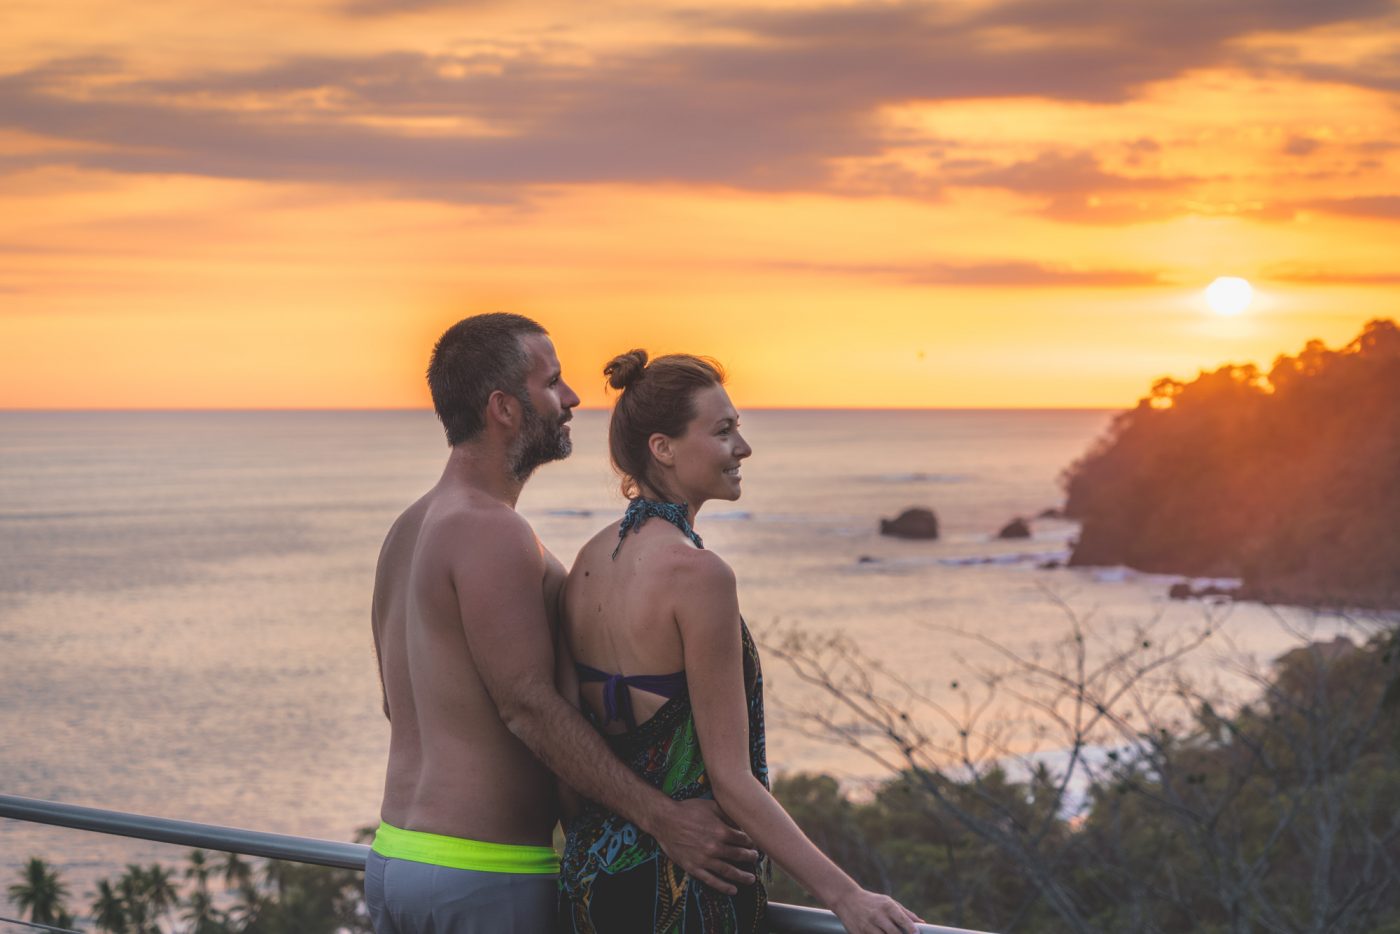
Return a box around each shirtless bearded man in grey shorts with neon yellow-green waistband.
[365,314,757,934]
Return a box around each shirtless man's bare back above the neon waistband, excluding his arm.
[374,483,564,846]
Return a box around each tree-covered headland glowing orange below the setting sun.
[1061,313,1400,606]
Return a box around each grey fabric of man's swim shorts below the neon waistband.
[364,850,559,934]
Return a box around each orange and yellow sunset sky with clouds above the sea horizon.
[0,0,1400,407]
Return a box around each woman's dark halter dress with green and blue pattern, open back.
[559,500,769,934]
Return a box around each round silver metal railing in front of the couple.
[0,794,979,934]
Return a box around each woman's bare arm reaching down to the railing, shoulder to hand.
[672,550,918,934]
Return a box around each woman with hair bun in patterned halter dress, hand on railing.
[560,350,918,934]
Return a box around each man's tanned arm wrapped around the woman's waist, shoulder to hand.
[451,510,757,893]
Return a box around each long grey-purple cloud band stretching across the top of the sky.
[0,0,1392,198]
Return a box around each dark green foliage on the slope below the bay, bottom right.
[774,632,1400,934]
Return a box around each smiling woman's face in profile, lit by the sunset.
[658,384,753,504]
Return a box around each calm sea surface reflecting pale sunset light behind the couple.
[0,412,1344,890]
